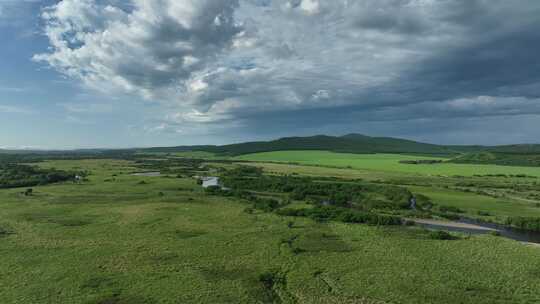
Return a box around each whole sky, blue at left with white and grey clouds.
[0,0,540,149]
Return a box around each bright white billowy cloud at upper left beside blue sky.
[34,0,241,99]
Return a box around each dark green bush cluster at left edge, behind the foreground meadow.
[0,164,78,188]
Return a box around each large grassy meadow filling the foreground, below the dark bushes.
[0,160,540,304]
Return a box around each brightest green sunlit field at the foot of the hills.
[236,151,540,177]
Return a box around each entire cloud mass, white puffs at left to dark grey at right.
[35,0,540,140]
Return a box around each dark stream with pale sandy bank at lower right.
[417,218,540,244]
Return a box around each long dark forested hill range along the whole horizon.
[6,134,540,166]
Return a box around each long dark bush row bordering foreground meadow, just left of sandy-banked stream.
[276,206,402,225]
